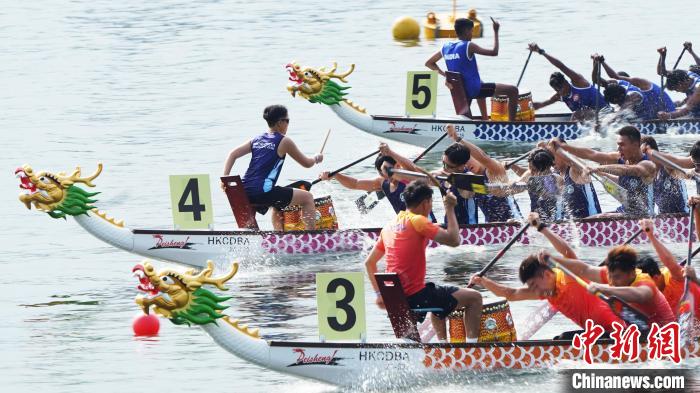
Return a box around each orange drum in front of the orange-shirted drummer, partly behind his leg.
[448,300,517,343]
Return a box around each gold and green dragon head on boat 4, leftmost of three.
[15,163,102,218]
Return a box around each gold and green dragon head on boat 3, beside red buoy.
[132,261,238,325]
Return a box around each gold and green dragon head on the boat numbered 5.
[286,61,355,105]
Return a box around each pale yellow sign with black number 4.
[170,175,214,229]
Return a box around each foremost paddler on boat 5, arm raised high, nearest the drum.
[528,42,610,120]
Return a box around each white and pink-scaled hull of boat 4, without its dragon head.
[76,212,688,267]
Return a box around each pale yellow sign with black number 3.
[316,272,367,340]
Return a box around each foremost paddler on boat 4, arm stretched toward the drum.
[318,143,418,213]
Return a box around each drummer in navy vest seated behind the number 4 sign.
[224,105,323,231]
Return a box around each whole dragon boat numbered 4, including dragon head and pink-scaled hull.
[15,164,689,267]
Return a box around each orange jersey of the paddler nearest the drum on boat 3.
[545,268,624,331]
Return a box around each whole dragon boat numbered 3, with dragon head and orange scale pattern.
[133,262,700,386]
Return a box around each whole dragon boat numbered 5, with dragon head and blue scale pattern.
[287,62,700,147]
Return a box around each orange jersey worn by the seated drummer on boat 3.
[376,210,440,296]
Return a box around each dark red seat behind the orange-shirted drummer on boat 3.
[374,273,443,342]
